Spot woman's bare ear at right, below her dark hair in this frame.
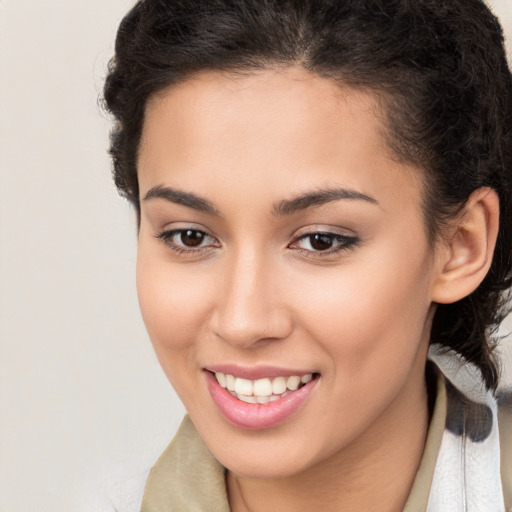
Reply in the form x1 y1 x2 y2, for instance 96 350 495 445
432 187 499 304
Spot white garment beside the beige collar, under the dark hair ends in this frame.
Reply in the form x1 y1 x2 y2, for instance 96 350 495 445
427 347 505 512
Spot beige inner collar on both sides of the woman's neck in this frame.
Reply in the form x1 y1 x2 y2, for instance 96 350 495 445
141 374 447 512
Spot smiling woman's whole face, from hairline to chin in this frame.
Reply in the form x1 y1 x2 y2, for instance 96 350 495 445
137 68 436 477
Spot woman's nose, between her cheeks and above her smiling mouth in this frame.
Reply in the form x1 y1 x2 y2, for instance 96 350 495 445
211 251 293 348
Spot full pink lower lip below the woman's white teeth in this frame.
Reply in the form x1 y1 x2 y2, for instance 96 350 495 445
204 371 318 430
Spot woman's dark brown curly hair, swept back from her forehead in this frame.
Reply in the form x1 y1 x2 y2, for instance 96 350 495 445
104 0 512 389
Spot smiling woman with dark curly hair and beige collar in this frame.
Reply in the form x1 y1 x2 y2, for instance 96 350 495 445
105 0 512 512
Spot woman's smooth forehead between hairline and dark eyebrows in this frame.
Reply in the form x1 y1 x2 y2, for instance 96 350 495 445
138 68 422 214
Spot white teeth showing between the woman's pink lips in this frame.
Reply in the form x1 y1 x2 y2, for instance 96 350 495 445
206 372 319 404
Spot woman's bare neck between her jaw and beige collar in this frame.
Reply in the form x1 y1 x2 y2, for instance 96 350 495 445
227 360 429 512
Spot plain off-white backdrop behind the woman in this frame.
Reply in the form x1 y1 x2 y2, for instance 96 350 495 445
0 0 512 512
